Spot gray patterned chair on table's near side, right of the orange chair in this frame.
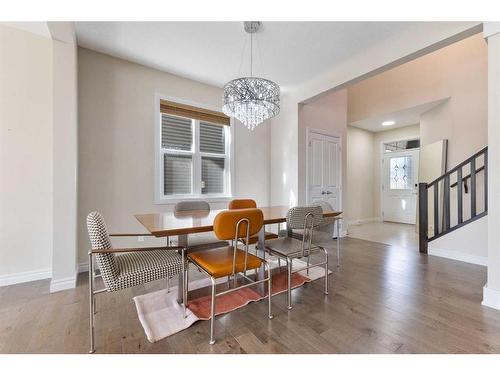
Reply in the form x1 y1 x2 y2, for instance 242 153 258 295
266 206 328 310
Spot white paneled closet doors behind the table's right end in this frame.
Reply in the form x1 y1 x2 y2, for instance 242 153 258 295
307 131 342 210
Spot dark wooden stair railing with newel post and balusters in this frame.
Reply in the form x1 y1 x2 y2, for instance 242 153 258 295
418 147 488 254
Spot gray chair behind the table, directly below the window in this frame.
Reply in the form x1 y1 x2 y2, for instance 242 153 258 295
173 200 228 252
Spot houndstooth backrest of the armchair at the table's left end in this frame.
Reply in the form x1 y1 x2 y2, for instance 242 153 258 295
87 211 119 290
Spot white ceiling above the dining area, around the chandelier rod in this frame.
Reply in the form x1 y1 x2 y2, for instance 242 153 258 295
75 22 425 88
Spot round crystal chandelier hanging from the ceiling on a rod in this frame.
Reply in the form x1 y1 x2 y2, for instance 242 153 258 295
222 21 280 130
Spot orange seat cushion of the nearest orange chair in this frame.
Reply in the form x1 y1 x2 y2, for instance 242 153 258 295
188 246 262 278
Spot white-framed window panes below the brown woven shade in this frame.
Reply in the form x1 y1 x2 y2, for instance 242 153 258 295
159 105 230 199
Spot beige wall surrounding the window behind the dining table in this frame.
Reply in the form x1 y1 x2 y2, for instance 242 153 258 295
78 48 270 263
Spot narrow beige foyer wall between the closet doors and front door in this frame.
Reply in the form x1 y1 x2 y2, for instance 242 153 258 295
345 126 376 224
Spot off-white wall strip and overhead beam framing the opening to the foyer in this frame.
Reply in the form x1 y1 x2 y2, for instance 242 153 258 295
271 22 481 209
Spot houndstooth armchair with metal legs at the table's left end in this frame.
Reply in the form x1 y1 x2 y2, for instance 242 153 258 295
87 212 184 353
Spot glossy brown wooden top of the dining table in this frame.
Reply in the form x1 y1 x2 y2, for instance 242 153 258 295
134 206 342 237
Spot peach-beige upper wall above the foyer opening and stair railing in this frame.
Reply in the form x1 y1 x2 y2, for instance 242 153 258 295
348 34 487 166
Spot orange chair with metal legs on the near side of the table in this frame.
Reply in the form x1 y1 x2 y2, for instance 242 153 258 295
183 208 273 344
